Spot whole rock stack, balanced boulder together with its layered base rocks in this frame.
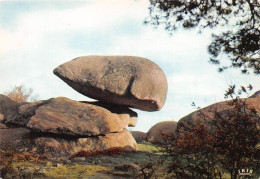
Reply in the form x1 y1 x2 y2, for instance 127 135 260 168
0 56 167 157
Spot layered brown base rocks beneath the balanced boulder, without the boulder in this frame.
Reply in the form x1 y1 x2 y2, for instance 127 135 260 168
0 97 138 157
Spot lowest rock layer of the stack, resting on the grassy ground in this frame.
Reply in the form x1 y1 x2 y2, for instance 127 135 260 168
0 128 138 158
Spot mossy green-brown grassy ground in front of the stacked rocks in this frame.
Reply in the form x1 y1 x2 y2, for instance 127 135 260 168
0 143 166 179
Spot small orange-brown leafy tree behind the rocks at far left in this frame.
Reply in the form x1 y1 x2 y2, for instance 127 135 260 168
5 85 38 103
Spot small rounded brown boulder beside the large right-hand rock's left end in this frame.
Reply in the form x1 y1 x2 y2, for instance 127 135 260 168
147 121 177 144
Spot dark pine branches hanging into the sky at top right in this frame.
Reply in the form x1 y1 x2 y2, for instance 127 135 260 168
145 0 260 74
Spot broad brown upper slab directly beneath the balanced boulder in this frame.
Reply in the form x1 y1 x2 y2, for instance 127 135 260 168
27 97 123 136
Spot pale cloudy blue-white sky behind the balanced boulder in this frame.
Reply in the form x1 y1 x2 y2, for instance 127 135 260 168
0 0 260 132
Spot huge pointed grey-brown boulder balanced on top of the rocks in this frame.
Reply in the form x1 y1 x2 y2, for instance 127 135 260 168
54 56 167 111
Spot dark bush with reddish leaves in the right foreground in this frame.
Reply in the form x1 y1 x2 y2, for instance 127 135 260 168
155 85 260 179
